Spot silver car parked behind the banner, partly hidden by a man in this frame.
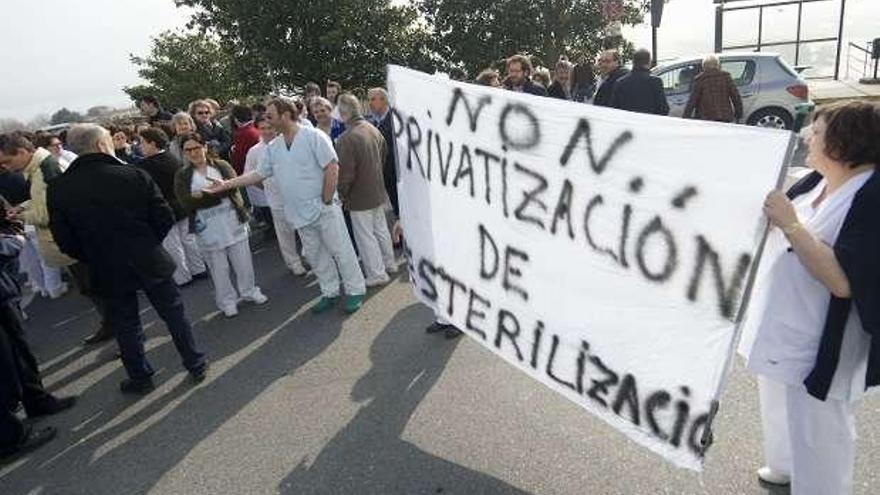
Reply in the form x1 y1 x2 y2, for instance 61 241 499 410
651 52 809 129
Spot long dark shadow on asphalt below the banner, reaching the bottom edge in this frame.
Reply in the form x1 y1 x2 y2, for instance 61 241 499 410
279 304 526 495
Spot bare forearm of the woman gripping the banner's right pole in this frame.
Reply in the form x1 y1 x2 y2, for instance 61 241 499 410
764 190 851 298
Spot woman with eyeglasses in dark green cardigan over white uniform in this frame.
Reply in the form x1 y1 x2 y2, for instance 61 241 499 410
174 133 269 318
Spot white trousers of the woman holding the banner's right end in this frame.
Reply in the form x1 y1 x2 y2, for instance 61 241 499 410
758 375 856 495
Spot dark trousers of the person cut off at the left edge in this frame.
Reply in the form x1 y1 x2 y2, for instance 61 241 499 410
0 301 54 448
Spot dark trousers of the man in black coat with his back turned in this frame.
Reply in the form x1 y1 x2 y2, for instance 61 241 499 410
104 278 205 380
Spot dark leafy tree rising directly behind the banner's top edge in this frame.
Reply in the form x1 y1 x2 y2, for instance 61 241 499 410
419 0 647 76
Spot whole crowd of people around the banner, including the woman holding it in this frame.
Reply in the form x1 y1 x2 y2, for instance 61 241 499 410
0 50 880 494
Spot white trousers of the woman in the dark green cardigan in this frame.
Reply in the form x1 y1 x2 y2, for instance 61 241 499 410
202 239 262 311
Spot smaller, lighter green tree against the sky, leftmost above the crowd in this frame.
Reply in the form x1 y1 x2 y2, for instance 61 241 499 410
123 31 269 108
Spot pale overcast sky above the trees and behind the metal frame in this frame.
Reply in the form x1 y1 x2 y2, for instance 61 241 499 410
0 0 880 121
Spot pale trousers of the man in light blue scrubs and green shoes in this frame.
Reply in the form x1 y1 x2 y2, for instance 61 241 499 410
297 204 367 297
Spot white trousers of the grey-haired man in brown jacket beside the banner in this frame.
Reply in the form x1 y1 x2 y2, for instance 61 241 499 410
351 206 395 282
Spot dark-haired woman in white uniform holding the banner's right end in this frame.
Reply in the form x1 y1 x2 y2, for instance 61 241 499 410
742 102 880 495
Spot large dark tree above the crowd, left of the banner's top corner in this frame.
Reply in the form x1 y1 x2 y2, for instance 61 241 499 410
176 0 433 89
